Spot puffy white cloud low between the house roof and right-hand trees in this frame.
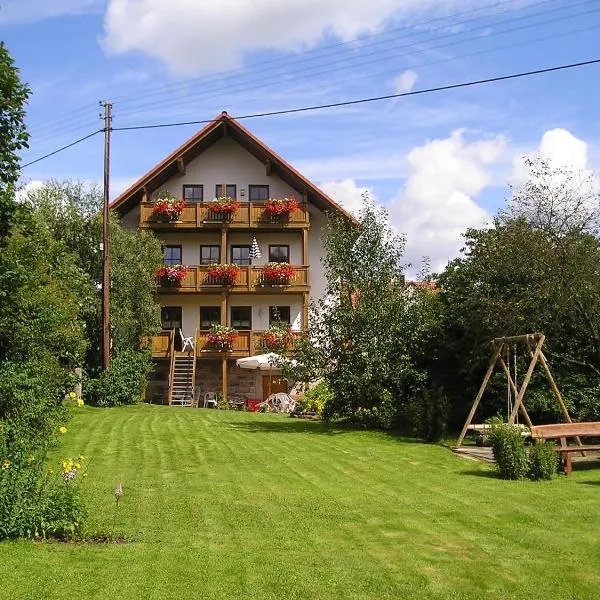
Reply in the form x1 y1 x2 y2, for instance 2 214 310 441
389 130 507 271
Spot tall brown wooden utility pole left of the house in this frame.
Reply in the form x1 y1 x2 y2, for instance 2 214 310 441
100 102 112 371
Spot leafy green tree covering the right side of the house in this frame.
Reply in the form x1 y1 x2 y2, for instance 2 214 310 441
296 198 436 428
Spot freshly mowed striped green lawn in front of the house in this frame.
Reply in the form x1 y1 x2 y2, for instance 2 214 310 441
0 405 600 599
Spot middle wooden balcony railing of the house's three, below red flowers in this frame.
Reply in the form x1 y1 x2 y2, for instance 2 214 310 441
158 265 310 294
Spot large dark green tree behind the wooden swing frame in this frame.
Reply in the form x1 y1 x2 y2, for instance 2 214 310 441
434 161 600 420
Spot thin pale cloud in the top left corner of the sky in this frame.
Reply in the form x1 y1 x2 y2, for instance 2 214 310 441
0 0 104 25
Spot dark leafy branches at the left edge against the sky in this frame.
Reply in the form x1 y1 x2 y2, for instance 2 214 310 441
0 42 29 245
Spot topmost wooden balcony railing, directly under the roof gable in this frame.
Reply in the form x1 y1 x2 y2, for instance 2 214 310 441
140 202 309 231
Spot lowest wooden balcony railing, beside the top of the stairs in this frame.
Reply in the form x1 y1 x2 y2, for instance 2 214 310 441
152 330 301 359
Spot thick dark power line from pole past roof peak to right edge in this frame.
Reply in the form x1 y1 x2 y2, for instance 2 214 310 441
113 58 600 131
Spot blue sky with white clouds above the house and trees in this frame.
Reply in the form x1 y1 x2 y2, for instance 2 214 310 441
0 0 600 270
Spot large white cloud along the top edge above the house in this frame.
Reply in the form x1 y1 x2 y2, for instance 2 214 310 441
104 0 462 75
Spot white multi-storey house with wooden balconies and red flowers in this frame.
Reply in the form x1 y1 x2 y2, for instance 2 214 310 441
112 113 352 404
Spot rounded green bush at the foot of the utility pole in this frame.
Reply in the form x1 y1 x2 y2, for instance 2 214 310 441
83 349 152 406
